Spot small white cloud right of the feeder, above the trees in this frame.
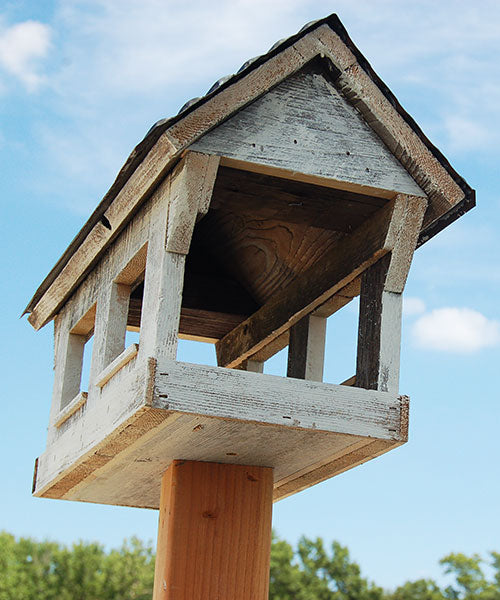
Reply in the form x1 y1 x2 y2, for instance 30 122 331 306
412 307 500 354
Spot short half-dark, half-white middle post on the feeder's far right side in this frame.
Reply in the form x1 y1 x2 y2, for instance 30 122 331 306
287 315 326 381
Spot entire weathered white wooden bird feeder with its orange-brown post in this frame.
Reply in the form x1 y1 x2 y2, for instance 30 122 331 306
26 15 474 600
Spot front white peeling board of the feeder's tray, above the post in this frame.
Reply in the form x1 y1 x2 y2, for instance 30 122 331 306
153 360 408 441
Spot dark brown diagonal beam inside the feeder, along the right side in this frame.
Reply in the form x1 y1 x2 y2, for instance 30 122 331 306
216 198 405 367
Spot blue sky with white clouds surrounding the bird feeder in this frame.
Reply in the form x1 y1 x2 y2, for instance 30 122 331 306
0 0 500 587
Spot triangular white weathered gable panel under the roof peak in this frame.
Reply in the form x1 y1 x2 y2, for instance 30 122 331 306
190 61 425 196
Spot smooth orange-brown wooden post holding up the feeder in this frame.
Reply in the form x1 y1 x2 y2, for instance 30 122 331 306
153 460 273 600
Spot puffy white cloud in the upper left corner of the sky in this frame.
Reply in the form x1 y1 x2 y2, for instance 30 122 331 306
0 21 51 91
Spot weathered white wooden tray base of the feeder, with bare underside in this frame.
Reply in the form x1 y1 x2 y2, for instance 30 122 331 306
33 359 408 509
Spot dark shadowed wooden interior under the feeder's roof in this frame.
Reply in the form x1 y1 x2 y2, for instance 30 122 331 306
128 167 387 341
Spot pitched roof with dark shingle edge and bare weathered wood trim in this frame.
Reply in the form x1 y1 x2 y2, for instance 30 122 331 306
23 15 475 326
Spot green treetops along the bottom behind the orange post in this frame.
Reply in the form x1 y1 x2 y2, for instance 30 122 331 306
0 532 500 600
